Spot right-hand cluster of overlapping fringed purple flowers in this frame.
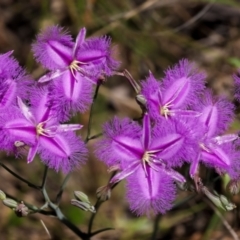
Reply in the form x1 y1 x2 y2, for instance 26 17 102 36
95 60 240 215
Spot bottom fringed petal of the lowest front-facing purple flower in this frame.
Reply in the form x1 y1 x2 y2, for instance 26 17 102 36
127 168 176 215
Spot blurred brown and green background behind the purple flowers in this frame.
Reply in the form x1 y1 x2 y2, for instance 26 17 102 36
0 0 240 240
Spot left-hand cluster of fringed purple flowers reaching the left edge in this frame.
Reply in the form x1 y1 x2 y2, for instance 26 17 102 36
0 26 118 173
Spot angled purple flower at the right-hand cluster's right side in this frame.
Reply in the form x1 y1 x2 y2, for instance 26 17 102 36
190 91 240 178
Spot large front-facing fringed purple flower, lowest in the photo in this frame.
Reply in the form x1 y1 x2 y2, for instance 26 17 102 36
96 114 190 215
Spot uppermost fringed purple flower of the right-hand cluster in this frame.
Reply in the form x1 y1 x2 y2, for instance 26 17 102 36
142 59 205 118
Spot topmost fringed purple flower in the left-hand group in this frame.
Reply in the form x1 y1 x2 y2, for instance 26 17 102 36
33 26 118 117
